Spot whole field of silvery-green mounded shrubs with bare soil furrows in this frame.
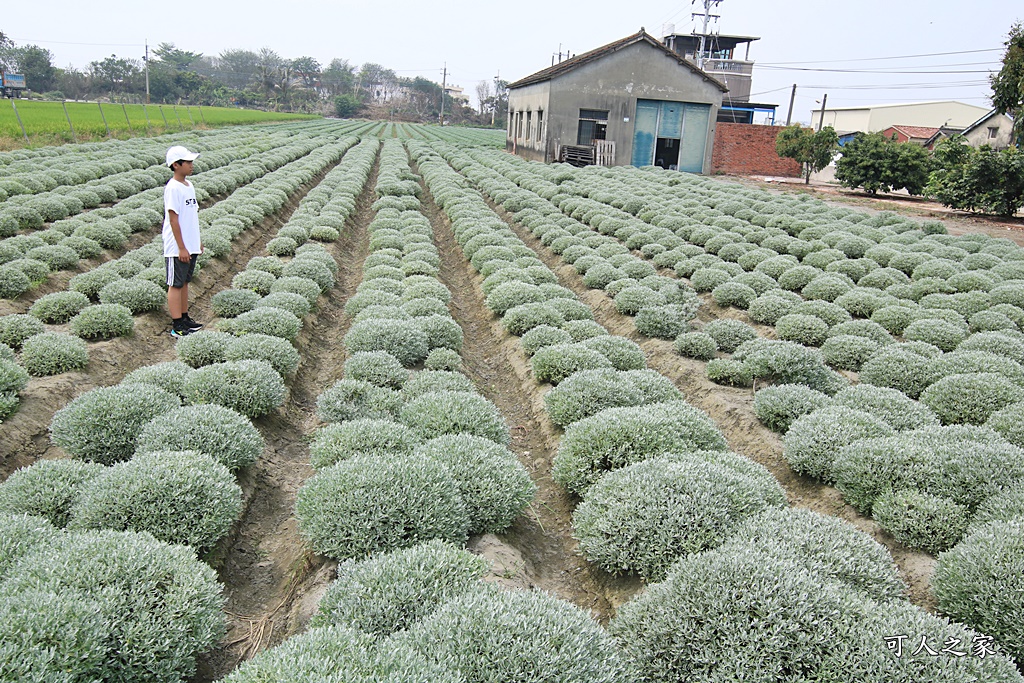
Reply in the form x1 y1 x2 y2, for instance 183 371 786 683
0 121 1024 683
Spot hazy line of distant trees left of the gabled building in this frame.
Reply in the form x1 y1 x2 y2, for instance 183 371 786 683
0 32 508 125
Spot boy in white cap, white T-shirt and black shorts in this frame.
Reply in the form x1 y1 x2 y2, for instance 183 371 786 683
164 145 203 339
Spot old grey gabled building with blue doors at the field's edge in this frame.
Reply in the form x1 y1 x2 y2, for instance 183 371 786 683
507 29 728 173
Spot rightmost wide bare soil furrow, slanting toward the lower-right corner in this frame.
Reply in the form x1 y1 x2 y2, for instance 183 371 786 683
492 200 935 609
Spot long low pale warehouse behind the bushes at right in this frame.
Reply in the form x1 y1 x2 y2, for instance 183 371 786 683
811 100 988 135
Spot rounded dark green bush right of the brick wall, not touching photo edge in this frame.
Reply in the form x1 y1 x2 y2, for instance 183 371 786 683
836 133 932 195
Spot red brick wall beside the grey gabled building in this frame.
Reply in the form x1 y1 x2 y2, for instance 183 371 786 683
711 123 801 178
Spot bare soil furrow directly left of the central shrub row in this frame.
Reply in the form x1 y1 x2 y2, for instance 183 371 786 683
194 147 378 683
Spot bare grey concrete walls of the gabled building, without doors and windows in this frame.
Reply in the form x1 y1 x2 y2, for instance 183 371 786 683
507 42 723 173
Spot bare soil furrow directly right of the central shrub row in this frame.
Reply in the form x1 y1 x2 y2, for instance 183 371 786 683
413 162 640 623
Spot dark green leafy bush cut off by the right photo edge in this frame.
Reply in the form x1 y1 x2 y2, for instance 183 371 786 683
928 135 1024 216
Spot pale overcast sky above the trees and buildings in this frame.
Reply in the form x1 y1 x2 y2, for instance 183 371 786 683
0 0 1024 123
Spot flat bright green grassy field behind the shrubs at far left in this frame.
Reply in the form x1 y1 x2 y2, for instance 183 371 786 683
0 100 317 148
